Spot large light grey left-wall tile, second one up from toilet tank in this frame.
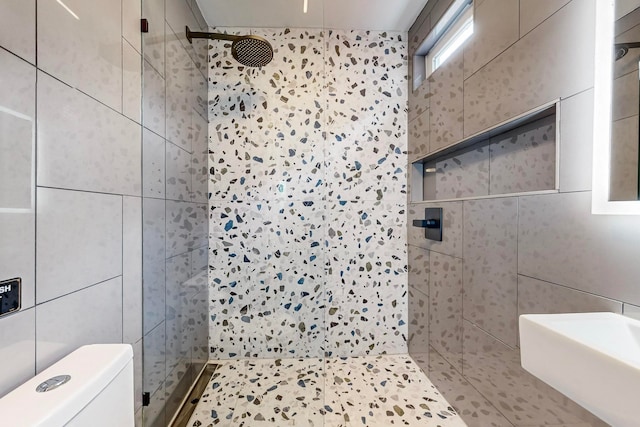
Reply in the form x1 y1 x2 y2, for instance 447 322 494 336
36 188 122 304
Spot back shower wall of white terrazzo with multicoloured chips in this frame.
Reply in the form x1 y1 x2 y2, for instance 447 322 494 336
209 28 407 359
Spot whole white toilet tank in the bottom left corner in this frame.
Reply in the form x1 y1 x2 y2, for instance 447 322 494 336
0 344 134 427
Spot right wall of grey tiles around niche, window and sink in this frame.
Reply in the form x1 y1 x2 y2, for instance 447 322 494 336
408 0 640 427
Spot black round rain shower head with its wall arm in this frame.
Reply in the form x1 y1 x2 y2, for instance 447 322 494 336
187 27 273 67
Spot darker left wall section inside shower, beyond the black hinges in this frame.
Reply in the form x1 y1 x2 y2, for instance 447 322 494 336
142 0 209 426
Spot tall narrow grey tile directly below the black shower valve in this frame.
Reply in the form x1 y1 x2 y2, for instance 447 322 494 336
429 252 462 371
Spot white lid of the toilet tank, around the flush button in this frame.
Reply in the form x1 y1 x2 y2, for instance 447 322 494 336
0 344 133 426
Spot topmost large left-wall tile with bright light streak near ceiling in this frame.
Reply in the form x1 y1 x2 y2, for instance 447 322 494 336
37 0 122 111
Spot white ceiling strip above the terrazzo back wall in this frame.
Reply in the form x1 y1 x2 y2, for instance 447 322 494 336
197 0 427 31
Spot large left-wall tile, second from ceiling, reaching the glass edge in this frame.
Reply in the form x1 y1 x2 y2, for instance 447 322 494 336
38 71 142 196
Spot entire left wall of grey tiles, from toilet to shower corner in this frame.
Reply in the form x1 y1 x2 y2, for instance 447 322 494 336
0 0 208 425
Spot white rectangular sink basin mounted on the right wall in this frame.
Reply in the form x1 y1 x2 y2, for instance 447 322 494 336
520 313 640 427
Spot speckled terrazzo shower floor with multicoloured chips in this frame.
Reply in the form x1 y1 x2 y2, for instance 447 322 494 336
187 355 466 427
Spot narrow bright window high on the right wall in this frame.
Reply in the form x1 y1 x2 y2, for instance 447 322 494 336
413 0 473 90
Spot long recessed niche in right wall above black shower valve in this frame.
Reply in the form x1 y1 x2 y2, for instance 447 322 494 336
411 102 559 201
